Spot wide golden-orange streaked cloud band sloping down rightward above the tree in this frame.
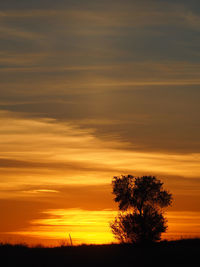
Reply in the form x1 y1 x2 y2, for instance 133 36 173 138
0 112 200 197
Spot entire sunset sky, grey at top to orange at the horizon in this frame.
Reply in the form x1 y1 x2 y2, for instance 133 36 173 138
0 0 200 245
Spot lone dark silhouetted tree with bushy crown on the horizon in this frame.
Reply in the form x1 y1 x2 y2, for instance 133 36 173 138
111 175 172 246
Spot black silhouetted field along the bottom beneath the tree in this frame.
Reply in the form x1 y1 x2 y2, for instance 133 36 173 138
0 239 200 267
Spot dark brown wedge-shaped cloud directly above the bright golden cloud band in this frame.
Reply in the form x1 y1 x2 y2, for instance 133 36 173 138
1 85 200 153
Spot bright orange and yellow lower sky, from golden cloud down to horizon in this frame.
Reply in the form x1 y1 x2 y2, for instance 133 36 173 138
0 111 200 245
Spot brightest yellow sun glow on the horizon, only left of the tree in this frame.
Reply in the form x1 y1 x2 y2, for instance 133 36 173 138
13 209 116 245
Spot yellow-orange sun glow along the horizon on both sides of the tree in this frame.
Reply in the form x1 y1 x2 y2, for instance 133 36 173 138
10 209 200 245
